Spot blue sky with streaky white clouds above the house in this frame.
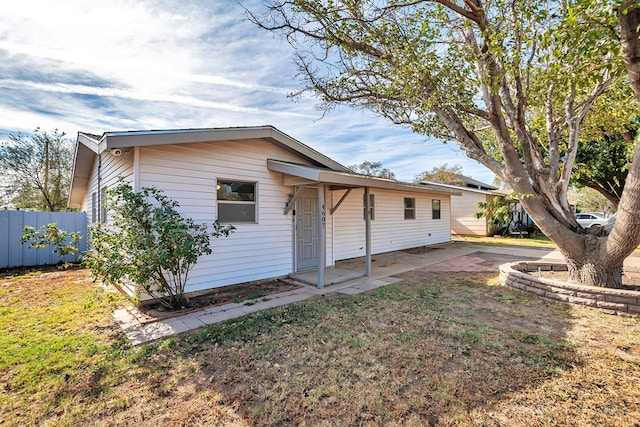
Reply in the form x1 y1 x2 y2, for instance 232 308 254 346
0 0 494 183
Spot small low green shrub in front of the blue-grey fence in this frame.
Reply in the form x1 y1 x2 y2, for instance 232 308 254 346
20 222 82 268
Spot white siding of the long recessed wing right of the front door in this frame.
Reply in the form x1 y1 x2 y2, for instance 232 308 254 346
332 189 451 261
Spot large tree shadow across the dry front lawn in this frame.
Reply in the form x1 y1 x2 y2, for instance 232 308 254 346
114 272 582 425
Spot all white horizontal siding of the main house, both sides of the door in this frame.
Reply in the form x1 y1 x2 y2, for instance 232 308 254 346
83 135 451 292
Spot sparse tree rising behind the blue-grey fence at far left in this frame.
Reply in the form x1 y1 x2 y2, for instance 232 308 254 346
0 128 73 212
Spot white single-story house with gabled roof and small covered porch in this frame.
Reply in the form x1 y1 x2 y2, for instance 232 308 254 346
69 126 460 298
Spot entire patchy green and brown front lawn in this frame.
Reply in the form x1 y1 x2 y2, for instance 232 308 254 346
0 270 640 427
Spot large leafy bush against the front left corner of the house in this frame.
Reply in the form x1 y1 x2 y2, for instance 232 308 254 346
84 180 235 309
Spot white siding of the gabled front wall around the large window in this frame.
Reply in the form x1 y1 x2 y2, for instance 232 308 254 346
138 140 312 292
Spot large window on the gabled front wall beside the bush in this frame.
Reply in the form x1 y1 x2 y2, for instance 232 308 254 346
216 179 257 224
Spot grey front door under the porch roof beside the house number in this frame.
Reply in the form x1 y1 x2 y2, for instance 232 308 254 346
296 189 318 270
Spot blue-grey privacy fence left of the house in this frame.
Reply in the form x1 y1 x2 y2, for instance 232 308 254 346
0 210 87 268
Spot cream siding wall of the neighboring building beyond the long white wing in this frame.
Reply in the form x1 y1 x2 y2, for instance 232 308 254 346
451 190 493 236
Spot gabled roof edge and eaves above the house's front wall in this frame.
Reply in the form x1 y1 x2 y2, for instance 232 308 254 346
68 126 350 207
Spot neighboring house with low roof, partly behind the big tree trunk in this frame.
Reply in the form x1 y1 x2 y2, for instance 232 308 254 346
417 175 505 236
